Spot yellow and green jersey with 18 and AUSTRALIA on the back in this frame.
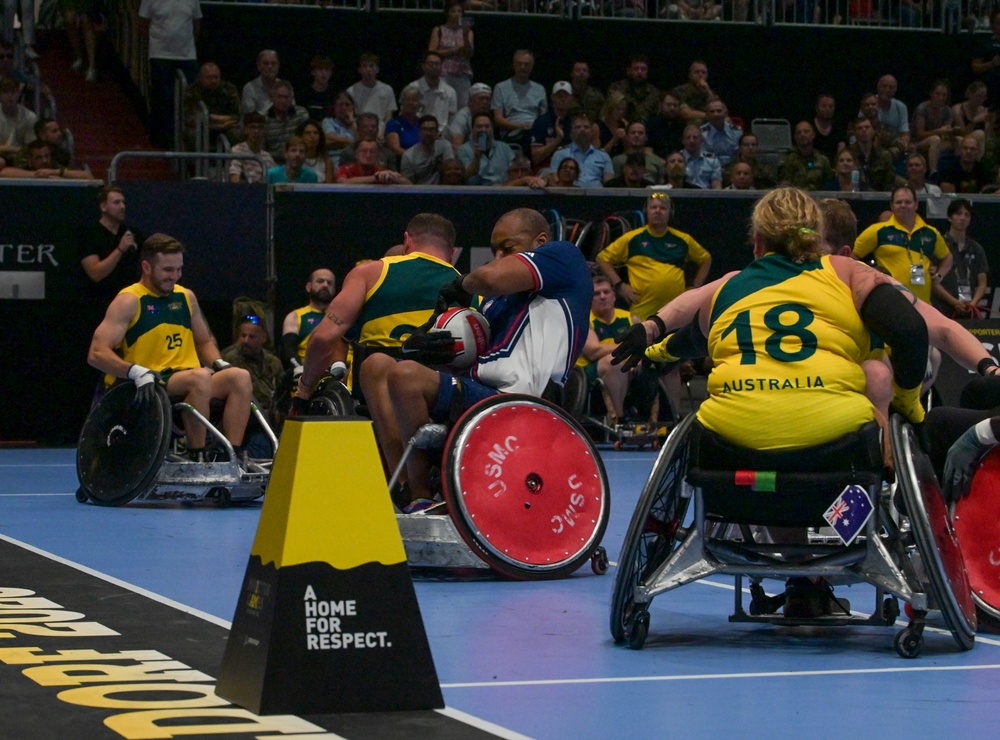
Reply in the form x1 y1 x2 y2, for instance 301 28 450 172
698 254 874 450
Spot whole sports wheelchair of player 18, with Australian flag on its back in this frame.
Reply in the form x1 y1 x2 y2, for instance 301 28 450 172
610 414 977 658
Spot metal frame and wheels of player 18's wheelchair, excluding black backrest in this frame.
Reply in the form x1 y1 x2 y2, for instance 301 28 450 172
610 414 976 658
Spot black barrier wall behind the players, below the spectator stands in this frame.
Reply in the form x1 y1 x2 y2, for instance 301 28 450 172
0 183 1000 444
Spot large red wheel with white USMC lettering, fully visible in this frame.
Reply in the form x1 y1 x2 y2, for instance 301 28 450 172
442 394 611 580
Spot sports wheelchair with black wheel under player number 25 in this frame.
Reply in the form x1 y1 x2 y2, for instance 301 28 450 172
76 383 278 506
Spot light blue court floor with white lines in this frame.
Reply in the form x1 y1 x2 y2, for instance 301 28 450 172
0 449 1000 740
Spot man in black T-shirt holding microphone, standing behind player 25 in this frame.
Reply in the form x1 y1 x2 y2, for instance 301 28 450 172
77 185 145 306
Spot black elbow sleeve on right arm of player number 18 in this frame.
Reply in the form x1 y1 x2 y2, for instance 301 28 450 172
861 283 927 388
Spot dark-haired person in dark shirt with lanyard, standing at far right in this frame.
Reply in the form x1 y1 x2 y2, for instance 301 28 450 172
931 198 990 319
